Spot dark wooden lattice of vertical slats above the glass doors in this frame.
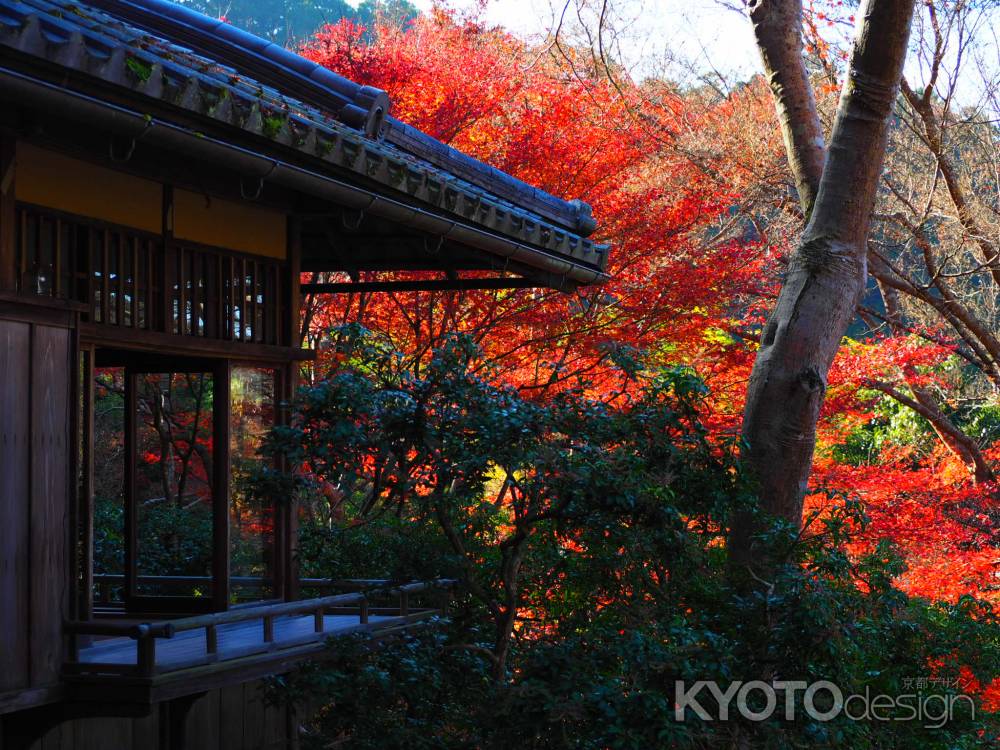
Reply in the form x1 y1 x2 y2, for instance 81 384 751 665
15 203 288 345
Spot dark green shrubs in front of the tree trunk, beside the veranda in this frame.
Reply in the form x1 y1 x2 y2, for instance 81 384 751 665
260 331 1000 750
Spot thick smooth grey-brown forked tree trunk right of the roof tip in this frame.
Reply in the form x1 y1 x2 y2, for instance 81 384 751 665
730 0 914 563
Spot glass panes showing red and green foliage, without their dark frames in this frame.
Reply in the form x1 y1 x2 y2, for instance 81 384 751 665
92 366 279 611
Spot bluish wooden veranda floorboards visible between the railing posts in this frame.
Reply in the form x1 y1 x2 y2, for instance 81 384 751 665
79 615 397 673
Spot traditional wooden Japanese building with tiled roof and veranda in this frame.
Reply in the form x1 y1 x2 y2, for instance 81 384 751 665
0 0 607 750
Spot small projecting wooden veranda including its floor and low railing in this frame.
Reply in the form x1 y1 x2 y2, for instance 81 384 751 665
62 580 454 705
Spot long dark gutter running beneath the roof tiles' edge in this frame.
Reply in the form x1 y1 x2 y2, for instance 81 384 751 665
0 67 610 291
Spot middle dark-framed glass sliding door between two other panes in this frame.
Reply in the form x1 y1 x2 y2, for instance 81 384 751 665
125 362 228 613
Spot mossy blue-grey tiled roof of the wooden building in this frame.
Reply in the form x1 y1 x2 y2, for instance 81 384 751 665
0 0 607 282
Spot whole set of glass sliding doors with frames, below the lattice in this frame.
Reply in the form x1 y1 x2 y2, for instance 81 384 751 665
84 349 282 616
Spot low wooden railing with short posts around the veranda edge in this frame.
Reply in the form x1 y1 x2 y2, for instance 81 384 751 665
64 579 456 678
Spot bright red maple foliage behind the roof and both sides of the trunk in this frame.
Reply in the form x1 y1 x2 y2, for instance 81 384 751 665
304 11 997 620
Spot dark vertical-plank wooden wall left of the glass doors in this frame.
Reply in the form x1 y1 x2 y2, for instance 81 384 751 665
0 305 74 695
